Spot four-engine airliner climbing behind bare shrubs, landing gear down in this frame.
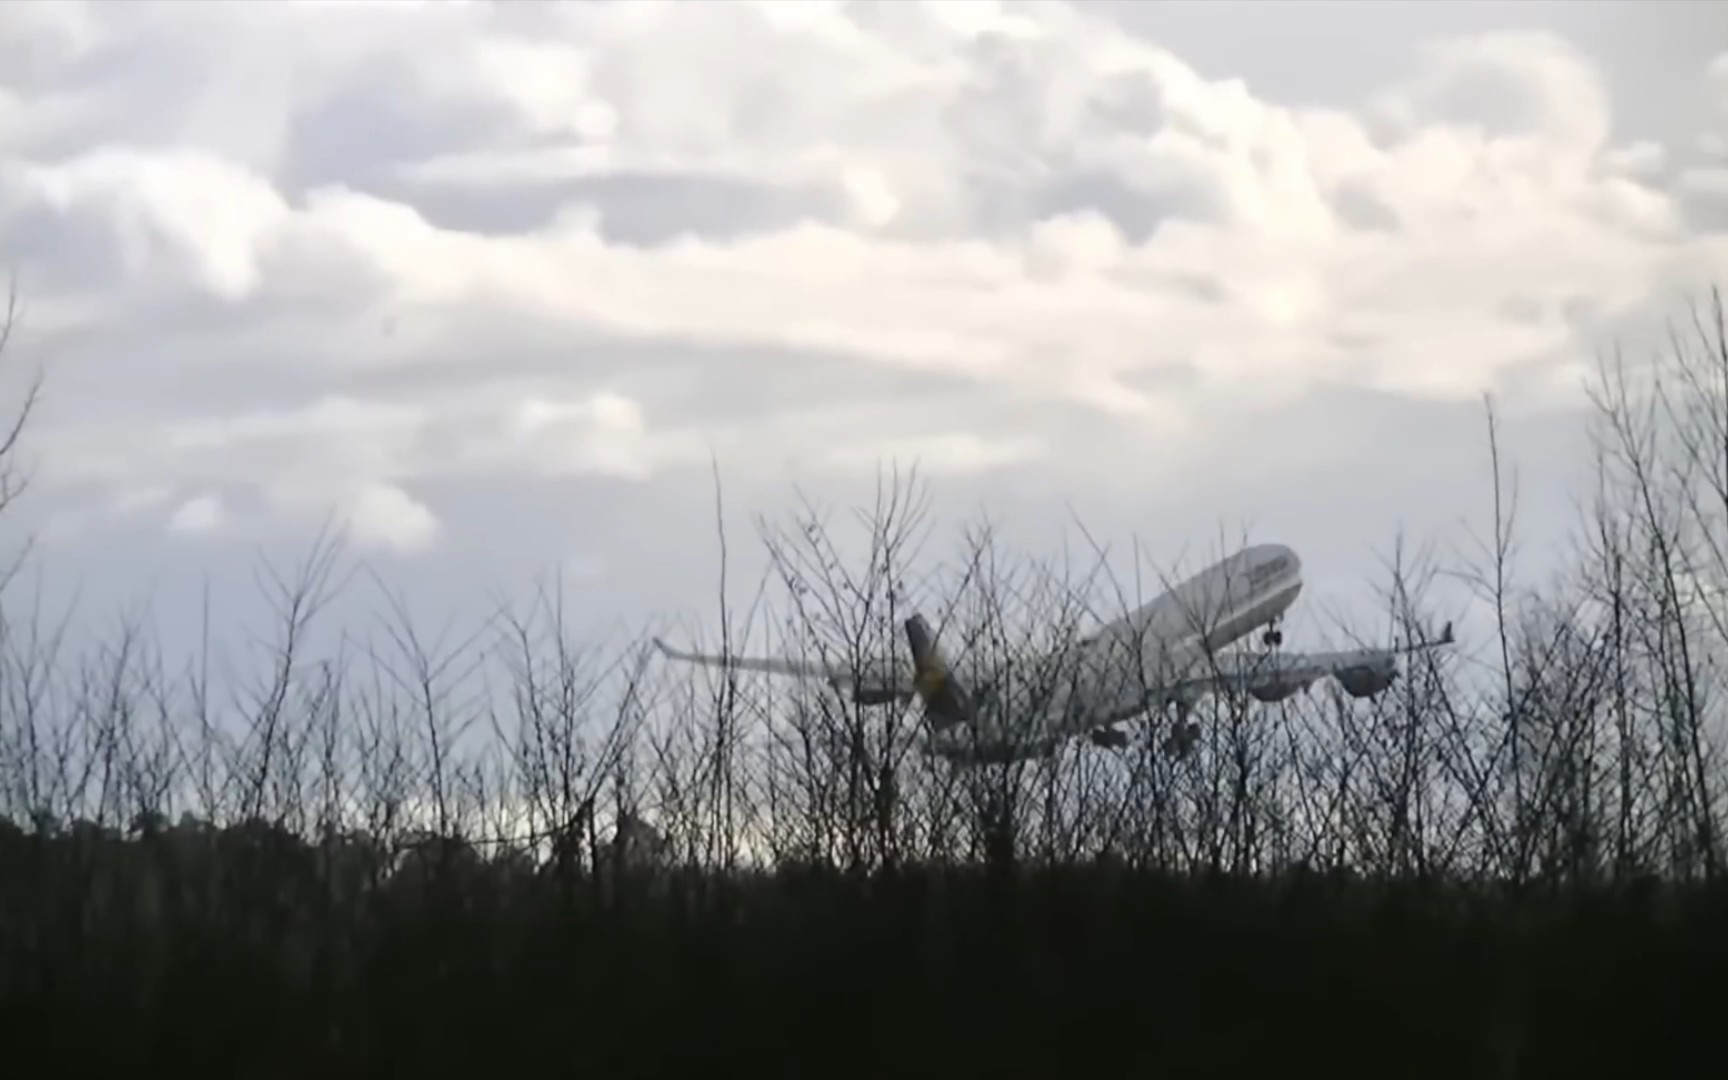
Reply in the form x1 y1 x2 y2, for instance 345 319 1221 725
655 544 1453 766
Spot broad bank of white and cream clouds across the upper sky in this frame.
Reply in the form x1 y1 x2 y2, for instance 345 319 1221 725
0 2 1728 577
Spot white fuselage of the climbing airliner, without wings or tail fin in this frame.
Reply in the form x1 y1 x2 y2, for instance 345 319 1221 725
930 544 1301 760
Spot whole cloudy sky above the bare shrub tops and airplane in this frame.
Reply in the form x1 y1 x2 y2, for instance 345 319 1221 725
0 0 1728 667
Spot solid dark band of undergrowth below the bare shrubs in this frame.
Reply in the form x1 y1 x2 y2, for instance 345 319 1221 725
10 828 1728 1077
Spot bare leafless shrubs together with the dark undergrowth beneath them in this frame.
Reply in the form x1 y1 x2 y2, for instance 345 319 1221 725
0 290 1728 1077
